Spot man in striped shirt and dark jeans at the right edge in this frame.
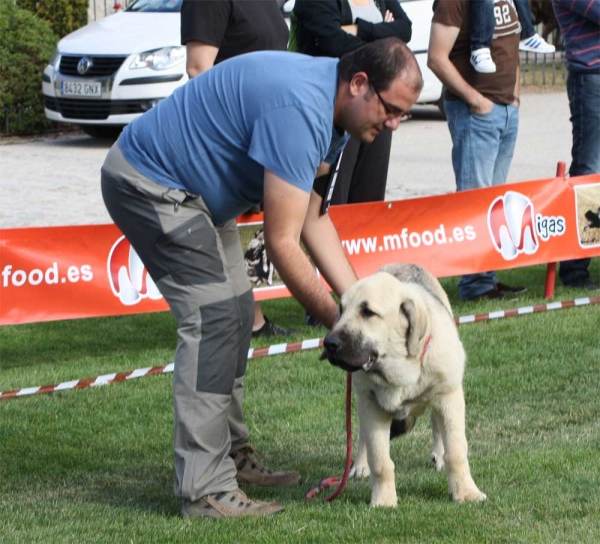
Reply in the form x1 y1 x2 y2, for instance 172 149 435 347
552 0 600 289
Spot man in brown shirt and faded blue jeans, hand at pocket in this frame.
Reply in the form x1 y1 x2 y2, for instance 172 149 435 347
428 0 526 300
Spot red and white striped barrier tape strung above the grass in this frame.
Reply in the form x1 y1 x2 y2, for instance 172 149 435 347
0 297 600 400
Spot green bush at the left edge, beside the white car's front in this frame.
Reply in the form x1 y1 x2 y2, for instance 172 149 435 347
0 0 58 134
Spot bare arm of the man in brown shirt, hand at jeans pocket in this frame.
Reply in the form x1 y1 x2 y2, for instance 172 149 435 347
427 23 494 113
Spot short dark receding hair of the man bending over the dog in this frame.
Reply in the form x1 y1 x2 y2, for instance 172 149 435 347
339 38 423 92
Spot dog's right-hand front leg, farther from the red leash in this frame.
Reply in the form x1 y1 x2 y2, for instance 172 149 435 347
432 389 487 502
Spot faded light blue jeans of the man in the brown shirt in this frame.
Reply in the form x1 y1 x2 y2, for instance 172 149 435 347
444 100 519 300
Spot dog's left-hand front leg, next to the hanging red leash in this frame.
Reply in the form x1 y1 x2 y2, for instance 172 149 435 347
357 396 398 506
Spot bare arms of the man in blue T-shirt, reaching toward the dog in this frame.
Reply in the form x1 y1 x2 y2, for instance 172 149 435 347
264 170 356 327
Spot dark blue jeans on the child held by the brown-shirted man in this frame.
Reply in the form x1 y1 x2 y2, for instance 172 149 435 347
469 0 535 51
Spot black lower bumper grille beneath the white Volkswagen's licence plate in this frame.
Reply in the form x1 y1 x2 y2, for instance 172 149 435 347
44 96 148 120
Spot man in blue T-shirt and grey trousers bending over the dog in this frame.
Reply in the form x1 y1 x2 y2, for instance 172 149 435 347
102 39 423 517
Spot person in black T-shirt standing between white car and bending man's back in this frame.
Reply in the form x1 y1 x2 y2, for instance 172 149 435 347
181 0 298 338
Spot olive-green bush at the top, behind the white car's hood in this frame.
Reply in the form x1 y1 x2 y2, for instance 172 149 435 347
16 0 88 38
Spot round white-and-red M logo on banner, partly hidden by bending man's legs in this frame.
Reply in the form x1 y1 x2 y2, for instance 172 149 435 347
107 236 162 306
